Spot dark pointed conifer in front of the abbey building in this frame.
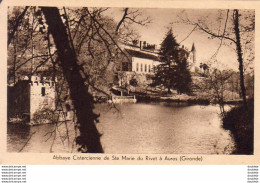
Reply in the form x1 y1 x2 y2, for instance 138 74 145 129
151 29 191 94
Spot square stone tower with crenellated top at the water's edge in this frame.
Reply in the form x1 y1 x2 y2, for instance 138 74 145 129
8 76 55 123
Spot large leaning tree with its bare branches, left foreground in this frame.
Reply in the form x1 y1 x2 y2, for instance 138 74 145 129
9 7 154 153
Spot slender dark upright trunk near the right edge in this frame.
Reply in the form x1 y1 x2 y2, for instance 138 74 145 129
234 10 247 108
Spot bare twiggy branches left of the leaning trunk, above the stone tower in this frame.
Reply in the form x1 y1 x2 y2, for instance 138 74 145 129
8 7 53 84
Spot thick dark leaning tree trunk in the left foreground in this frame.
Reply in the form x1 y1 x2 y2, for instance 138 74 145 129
41 7 103 153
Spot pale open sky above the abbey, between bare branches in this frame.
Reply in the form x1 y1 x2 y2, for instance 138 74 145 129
103 8 254 70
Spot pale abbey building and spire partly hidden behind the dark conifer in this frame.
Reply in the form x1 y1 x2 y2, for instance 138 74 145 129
118 41 200 91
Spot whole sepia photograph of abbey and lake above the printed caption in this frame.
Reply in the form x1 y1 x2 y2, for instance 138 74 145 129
6 6 255 155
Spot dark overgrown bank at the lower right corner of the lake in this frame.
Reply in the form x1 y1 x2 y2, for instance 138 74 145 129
223 99 254 154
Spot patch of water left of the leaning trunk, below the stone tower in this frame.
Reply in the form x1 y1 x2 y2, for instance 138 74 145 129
7 122 76 152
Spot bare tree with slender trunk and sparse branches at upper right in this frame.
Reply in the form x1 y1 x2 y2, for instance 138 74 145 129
179 9 255 108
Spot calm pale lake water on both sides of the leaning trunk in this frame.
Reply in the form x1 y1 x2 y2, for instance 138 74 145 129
7 103 234 154
